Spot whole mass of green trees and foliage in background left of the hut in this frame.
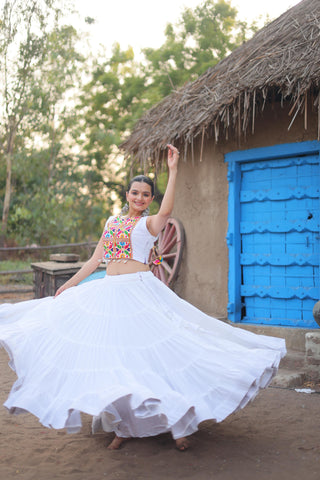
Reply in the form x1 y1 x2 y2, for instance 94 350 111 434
0 0 255 244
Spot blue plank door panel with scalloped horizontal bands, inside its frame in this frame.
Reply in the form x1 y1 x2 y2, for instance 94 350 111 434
240 156 320 327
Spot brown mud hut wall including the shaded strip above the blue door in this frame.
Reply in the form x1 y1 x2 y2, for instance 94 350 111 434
173 104 318 318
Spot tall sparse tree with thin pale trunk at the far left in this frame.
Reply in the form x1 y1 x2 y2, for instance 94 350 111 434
0 0 81 242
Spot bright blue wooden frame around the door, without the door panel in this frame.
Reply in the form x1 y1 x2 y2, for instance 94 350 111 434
225 140 320 323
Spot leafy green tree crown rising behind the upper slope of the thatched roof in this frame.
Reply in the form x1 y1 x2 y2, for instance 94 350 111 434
143 0 256 102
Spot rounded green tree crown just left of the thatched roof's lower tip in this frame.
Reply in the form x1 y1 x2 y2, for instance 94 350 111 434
78 44 145 160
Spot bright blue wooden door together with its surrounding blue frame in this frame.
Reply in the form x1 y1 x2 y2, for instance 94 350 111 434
226 142 320 328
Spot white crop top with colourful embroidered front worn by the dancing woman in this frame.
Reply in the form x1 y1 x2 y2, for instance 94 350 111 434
103 215 157 263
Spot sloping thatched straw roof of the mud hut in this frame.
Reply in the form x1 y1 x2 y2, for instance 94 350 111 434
121 0 320 164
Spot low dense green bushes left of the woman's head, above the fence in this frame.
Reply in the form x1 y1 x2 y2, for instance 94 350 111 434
9 144 110 245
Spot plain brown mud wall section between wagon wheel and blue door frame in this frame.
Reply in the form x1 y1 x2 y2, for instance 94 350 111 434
173 142 228 316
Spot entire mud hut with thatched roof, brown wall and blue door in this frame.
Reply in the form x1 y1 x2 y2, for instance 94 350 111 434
122 0 320 328
